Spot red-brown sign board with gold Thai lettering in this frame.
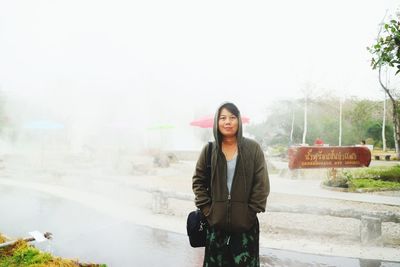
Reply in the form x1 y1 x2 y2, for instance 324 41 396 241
288 146 371 169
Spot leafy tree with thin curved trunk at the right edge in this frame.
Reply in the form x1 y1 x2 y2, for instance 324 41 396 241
368 13 400 158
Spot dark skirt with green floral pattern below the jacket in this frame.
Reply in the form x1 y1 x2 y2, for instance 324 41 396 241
203 220 260 267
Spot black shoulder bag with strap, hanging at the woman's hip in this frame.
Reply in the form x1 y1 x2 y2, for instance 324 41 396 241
186 142 212 248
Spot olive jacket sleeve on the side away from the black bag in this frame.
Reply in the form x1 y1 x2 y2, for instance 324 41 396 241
249 145 270 213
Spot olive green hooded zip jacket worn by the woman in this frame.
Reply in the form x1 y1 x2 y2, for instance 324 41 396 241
192 104 270 232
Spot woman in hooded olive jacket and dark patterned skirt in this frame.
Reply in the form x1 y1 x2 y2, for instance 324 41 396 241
193 103 269 267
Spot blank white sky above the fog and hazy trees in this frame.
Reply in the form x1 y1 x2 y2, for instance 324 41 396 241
0 0 399 150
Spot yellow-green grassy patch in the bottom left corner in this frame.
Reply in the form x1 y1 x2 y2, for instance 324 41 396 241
0 238 106 267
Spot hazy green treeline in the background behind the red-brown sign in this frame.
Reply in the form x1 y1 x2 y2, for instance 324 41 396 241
246 95 394 148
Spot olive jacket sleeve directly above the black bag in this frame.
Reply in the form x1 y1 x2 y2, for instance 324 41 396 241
192 145 211 213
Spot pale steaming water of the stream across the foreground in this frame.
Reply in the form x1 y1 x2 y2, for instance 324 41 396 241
0 185 400 267
